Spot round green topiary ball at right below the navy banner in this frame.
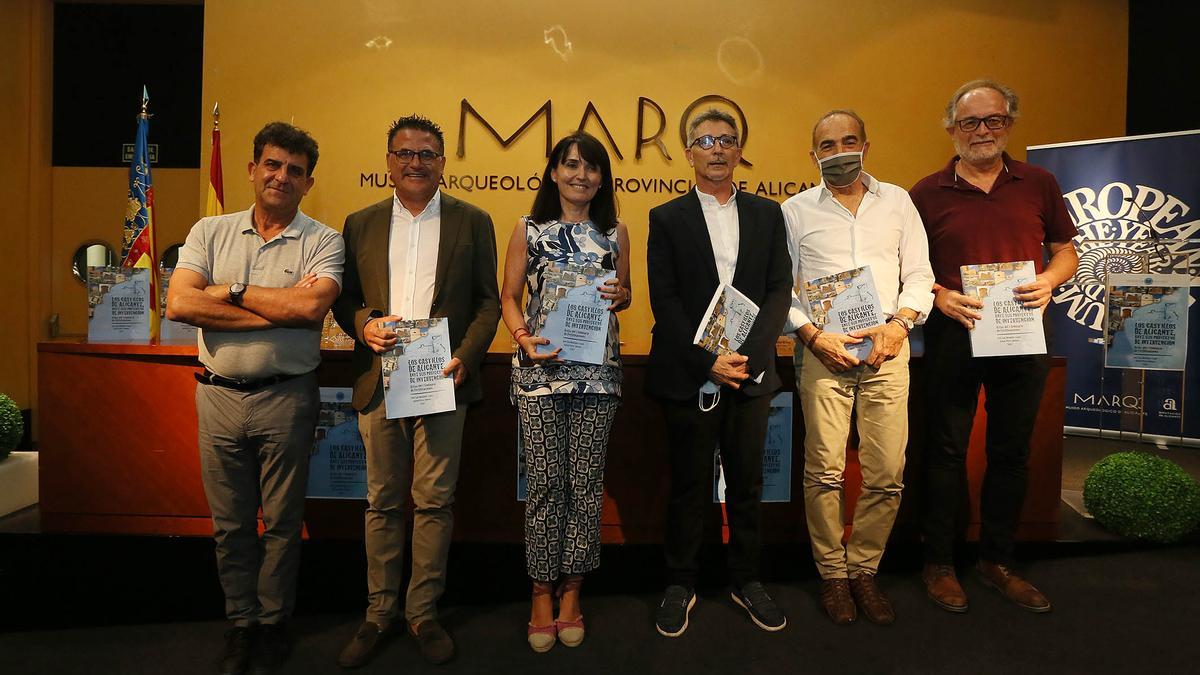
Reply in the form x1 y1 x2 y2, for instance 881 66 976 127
1084 453 1200 543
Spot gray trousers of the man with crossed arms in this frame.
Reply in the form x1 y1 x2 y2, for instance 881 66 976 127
196 372 320 626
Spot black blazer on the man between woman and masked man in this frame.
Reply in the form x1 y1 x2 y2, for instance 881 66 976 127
646 191 792 400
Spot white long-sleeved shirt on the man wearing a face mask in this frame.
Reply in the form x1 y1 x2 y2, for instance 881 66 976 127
784 172 934 334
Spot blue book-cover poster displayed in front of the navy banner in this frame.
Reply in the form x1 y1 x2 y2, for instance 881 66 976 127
1104 274 1192 371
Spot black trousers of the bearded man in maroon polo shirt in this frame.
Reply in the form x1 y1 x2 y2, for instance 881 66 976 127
922 310 1050 565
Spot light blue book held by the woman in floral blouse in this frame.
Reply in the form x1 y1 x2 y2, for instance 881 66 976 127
533 263 617 365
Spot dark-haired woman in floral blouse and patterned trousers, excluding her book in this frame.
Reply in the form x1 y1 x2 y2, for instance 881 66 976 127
500 132 630 652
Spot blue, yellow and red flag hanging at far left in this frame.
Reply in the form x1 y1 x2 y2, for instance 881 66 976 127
121 86 158 339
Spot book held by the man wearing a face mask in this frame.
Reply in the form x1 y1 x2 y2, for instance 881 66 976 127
804 265 883 360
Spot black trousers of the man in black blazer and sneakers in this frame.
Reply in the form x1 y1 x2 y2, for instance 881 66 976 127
662 388 770 589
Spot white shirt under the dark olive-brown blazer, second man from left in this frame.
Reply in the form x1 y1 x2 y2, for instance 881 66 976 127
388 190 442 321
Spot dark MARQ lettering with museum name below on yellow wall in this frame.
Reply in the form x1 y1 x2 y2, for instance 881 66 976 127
359 94 811 198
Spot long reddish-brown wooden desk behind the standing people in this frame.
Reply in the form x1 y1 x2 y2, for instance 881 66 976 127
38 341 1066 543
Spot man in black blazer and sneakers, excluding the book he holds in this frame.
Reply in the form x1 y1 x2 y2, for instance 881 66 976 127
646 109 792 638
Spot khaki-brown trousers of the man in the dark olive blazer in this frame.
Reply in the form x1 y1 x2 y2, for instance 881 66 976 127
359 394 467 628
